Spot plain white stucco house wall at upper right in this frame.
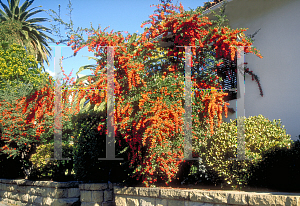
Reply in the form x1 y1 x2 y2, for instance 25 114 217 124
212 0 300 140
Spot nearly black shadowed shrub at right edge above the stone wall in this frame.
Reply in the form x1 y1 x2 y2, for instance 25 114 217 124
249 140 300 192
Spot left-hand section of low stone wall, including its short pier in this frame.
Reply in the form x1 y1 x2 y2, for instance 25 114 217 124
0 179 114 206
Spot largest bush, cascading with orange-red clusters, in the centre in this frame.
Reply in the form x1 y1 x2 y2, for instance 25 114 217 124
55 1 261 186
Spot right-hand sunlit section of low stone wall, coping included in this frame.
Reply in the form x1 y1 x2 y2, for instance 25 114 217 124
114 187 300 206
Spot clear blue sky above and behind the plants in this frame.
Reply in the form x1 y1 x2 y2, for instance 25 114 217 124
27 0 205 80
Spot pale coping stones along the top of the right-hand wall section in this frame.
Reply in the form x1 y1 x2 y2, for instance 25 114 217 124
114 186 300 206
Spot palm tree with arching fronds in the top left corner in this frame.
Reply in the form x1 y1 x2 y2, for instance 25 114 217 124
0 0 54 66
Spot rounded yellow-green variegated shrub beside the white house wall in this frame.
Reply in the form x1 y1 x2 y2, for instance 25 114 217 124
191 115 292 188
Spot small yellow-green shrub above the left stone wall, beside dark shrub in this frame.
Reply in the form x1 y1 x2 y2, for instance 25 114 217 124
29 143 73 181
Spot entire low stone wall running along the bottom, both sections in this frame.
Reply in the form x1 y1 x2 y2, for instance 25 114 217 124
0 179 300 206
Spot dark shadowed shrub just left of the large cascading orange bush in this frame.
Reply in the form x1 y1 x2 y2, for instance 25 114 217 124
72 110 131 182
